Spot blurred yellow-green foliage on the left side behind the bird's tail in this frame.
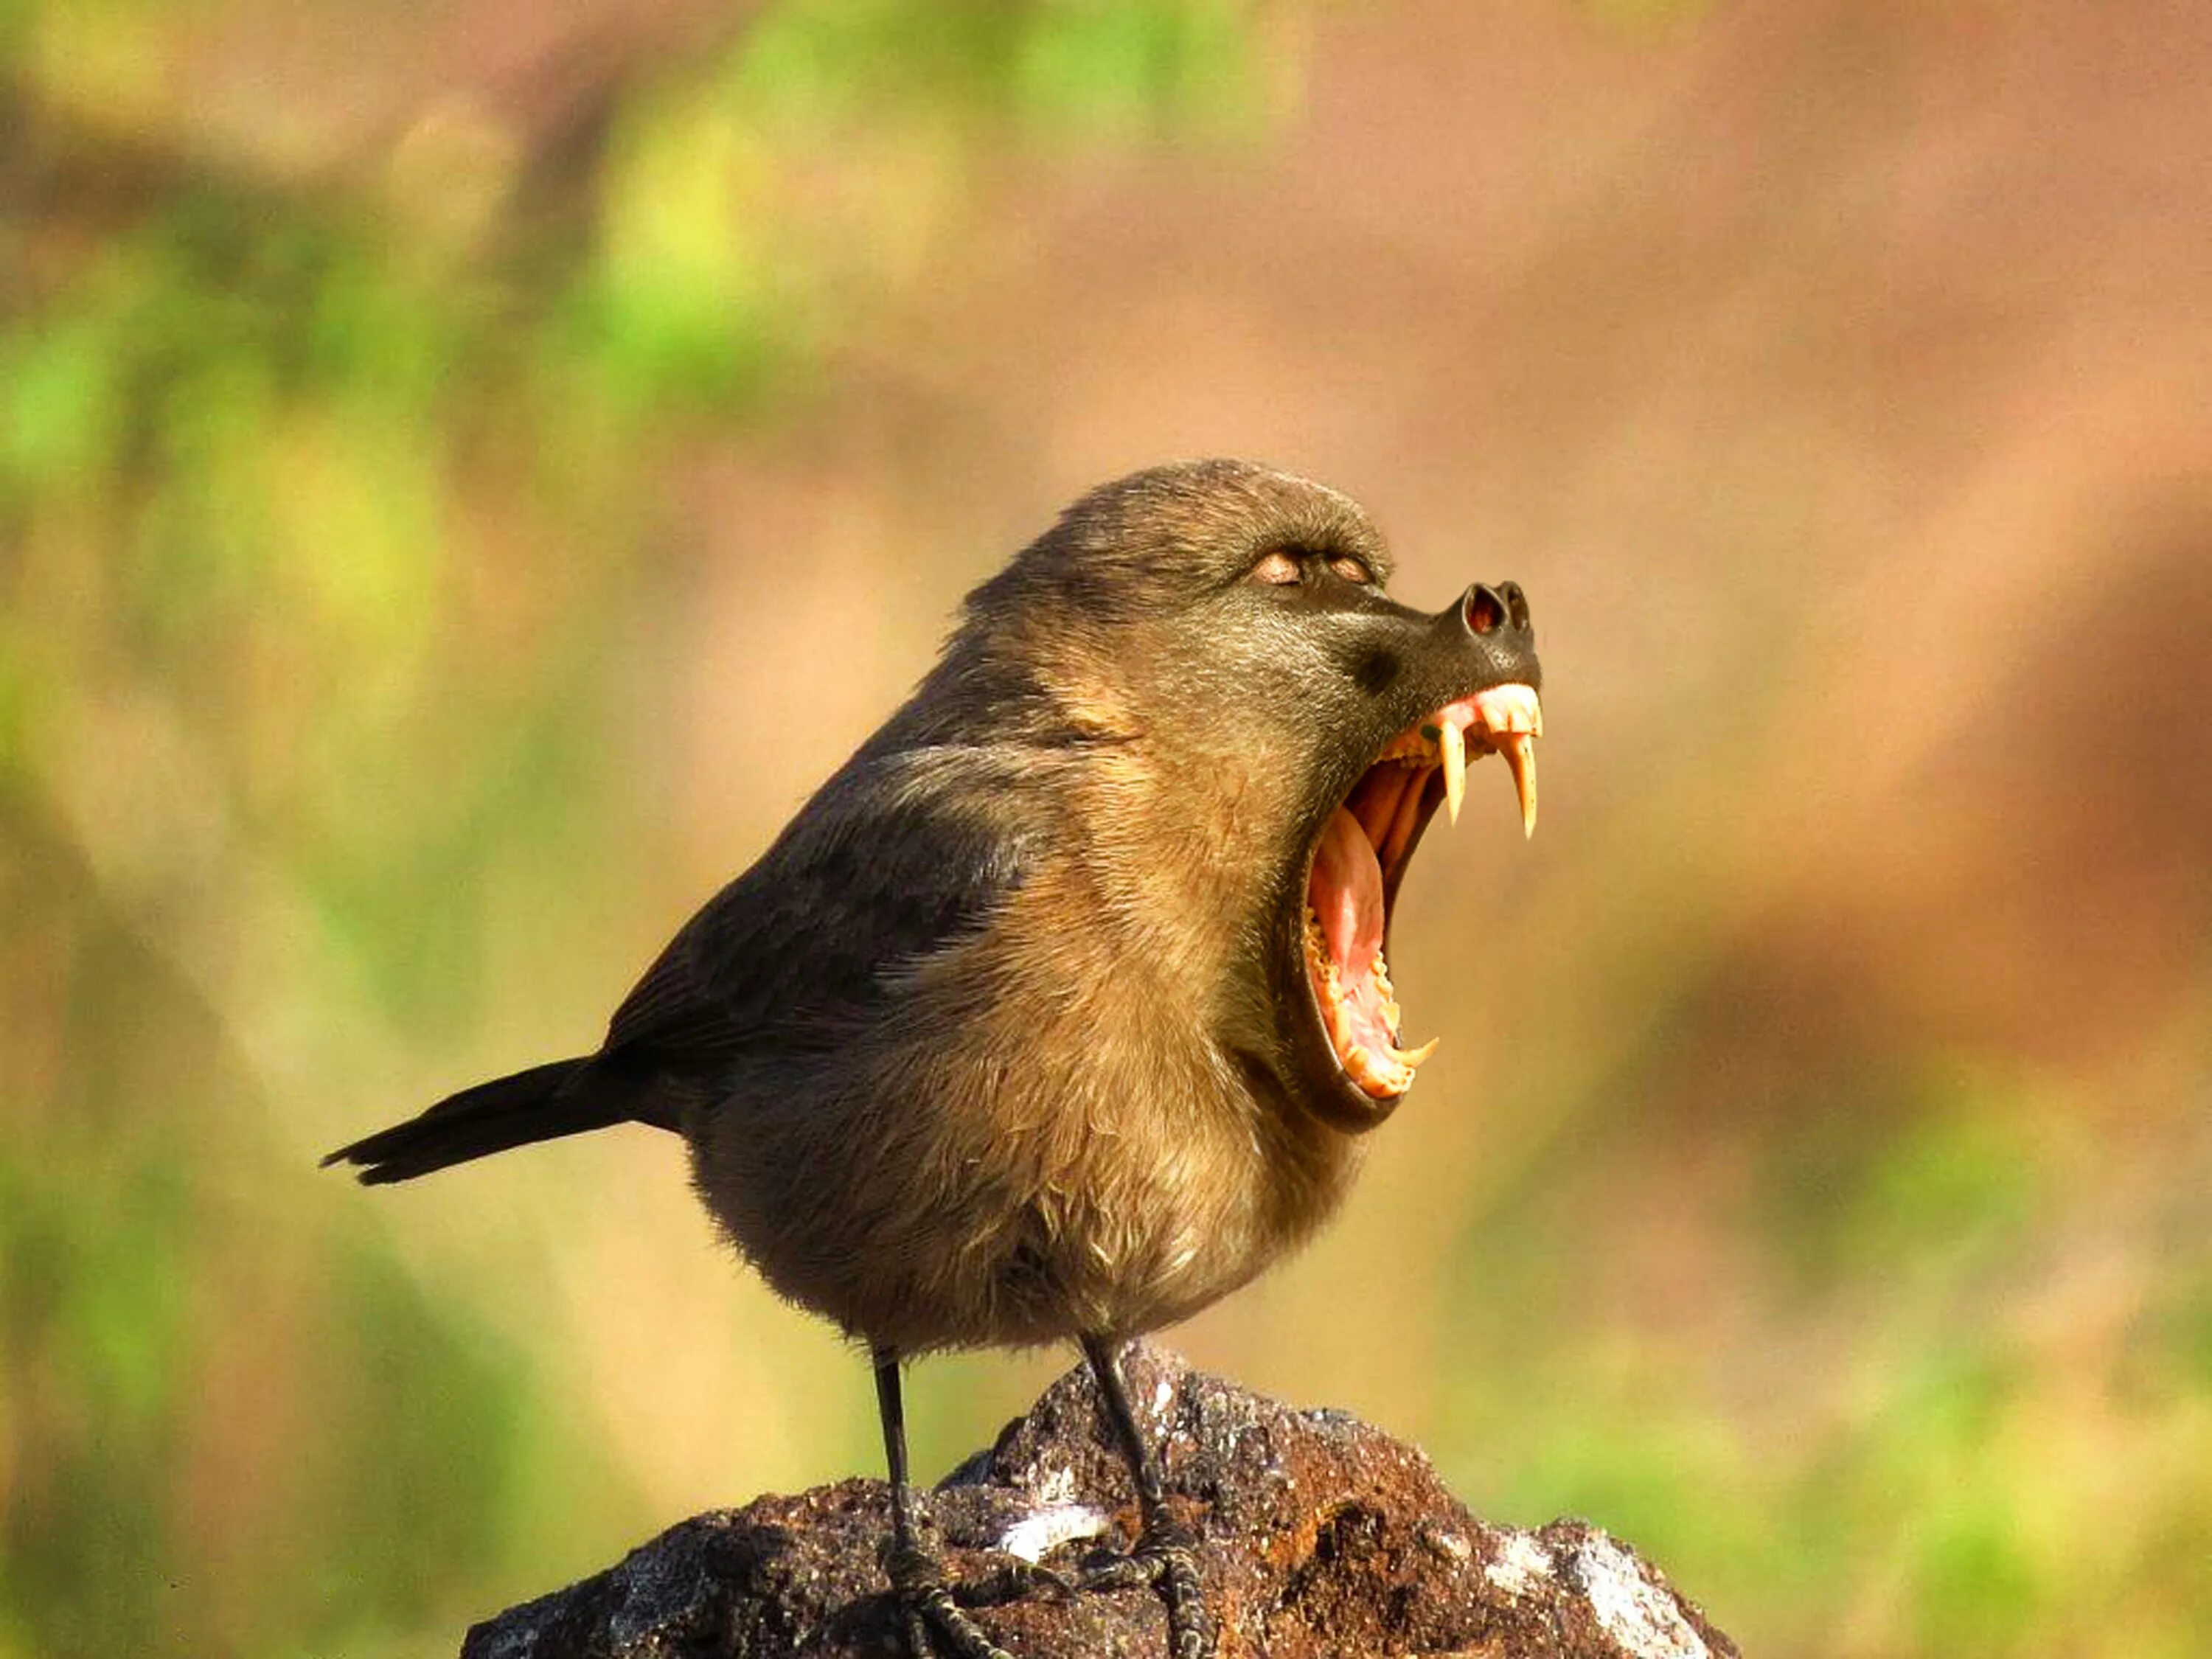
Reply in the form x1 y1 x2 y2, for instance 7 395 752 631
0 0 1274 1659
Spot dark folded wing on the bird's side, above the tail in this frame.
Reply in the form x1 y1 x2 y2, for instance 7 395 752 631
606 748 1046 1075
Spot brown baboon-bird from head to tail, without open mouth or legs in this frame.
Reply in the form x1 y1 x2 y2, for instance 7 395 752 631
336 462 1535 1354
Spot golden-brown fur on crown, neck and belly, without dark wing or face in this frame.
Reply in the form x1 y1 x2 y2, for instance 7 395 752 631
686 462 1416 1352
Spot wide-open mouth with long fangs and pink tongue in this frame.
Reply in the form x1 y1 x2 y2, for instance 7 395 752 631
1305 684 1544 1099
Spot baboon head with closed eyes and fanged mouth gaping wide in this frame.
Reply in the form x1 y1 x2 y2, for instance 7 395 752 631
940 460 1542 1133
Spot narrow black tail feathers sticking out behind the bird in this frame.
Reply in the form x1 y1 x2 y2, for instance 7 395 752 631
323 1057 653 1186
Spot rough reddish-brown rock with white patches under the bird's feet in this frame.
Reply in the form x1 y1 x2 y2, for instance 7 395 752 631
462 1347 1736 1659
